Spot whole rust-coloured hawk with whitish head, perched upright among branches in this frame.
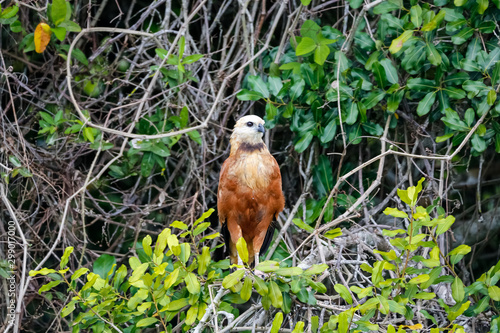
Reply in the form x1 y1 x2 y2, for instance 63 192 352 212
217 116 285 265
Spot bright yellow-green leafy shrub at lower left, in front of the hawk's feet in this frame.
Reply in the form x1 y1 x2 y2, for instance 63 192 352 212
30 209 328 332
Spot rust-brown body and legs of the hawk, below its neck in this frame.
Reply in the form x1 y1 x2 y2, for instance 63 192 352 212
217 150 285 263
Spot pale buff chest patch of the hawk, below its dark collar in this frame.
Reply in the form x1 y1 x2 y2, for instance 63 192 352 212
231 153 273 190
